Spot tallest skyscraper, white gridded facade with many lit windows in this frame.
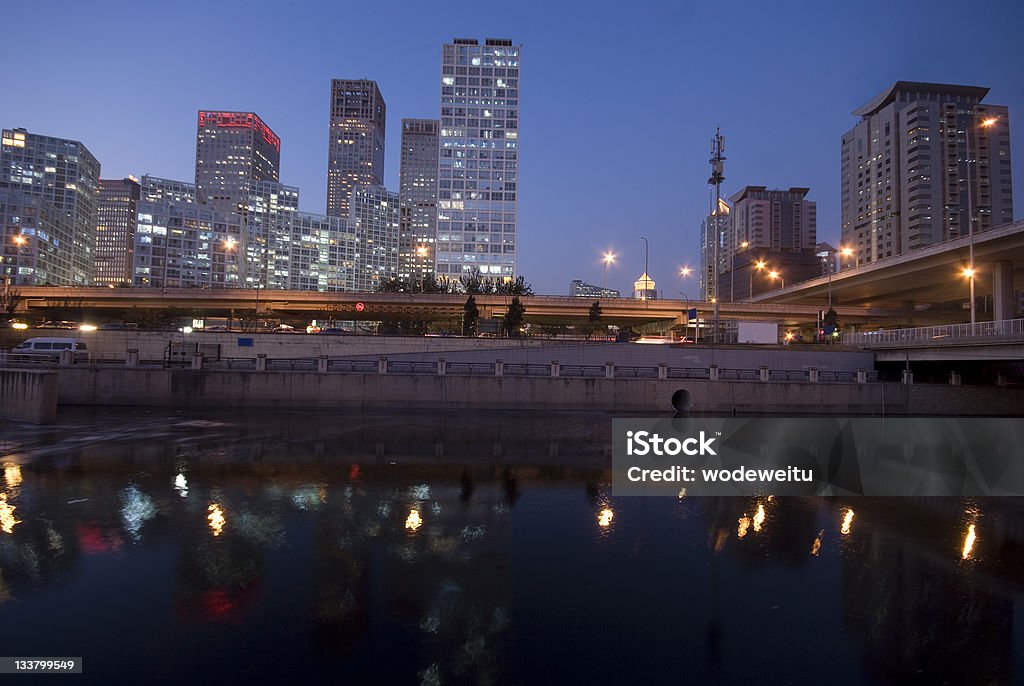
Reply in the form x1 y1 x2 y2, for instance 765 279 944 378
436 38 520 278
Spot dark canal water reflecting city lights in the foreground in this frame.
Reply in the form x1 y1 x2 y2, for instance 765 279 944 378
0 409 1024 685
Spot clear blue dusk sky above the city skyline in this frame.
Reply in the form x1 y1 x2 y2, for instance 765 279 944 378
0 0 1024 298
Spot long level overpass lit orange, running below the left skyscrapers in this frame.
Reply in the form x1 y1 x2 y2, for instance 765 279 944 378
6 287 912 327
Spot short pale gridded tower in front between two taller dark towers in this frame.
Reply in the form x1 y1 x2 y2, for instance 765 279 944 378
348 185 399 291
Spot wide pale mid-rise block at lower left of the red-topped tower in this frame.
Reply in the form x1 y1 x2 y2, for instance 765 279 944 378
132 181 246 289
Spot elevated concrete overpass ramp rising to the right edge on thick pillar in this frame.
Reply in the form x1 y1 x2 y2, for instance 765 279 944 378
750 221 1024 325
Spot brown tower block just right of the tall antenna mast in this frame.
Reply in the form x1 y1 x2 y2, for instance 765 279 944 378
718 185 821 302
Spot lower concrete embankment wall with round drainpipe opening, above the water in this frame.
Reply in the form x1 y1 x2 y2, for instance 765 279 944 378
49 367 1024 416
